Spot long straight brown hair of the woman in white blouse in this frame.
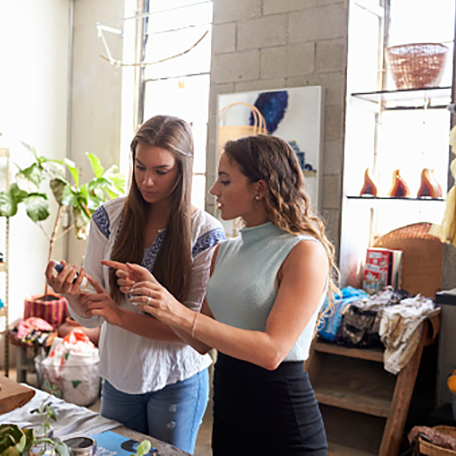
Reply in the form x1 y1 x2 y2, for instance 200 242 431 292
109 116 193 302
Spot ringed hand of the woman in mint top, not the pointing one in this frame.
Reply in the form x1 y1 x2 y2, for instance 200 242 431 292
130 276 194 327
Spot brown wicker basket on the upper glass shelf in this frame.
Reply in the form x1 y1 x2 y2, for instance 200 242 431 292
386 43 448 89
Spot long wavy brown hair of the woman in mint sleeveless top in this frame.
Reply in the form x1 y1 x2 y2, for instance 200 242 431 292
224 135 340 314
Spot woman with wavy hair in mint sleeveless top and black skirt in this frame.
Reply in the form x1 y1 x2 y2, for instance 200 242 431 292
107 135 338 456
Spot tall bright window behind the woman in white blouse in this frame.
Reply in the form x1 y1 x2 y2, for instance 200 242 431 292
138 0 212 209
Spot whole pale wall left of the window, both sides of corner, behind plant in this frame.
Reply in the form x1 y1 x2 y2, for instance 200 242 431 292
0 0 131 364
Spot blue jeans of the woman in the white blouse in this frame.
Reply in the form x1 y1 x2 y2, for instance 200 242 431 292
100 369 209 454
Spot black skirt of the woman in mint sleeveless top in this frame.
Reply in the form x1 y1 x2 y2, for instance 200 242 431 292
212 352 327 456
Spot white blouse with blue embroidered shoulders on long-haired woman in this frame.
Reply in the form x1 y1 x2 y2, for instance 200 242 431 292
70 198 226 394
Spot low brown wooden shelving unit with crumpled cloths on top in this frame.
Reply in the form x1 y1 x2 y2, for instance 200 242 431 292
306 317 438 456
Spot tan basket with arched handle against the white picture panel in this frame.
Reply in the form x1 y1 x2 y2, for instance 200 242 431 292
218 101 268 157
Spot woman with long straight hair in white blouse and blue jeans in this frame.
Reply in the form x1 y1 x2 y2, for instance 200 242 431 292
46 116 225 453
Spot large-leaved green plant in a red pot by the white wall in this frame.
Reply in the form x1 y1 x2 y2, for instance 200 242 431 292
0 143 125 326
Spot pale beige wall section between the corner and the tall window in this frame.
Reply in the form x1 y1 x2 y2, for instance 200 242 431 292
67 0 136 264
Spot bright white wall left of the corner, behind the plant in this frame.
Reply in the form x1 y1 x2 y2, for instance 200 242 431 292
0 0 70 328
